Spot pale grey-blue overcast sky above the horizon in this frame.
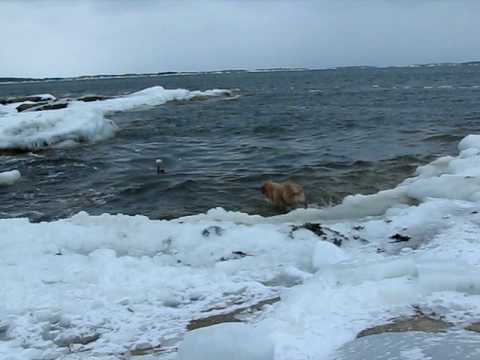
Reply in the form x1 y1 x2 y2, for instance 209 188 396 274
0 0 480 77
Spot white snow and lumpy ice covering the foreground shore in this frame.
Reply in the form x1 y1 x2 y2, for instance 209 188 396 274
0 136 480 360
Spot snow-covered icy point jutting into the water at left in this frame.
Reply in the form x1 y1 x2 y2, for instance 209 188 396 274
0 86 230 150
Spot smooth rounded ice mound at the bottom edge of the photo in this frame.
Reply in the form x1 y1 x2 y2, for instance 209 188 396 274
178 323 274 360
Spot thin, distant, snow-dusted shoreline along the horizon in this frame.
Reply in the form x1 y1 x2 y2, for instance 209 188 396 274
0 61 480 85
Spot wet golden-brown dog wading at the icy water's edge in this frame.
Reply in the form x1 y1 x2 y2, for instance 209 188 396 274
260 180 307 210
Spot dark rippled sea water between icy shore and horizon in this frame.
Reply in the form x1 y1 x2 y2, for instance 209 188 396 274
0 65 480 221
